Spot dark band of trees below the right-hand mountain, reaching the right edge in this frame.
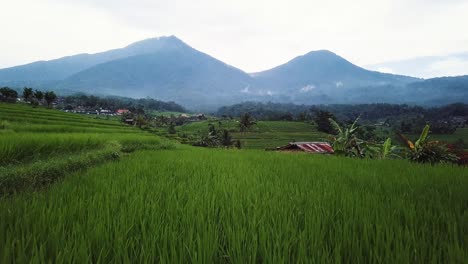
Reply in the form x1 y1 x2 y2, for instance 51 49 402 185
216 102 468 134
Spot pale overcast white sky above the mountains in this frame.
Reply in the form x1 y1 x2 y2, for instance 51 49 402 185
0 0 468 75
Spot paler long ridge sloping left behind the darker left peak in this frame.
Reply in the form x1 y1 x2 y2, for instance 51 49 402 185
0 36 187 86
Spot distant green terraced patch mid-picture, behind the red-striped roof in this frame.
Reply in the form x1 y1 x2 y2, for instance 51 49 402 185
177 121 326 149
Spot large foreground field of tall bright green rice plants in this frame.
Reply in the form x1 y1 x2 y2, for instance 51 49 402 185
0 147 468 263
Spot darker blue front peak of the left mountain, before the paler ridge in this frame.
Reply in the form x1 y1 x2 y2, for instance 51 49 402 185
57 41 252 107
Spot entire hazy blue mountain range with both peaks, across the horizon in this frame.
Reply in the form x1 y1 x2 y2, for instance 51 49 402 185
0 36 468 109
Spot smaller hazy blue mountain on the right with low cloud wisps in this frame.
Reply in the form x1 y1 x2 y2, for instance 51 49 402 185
252 50 419 102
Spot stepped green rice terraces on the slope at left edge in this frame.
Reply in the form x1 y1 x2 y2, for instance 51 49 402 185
0 104 172 195
